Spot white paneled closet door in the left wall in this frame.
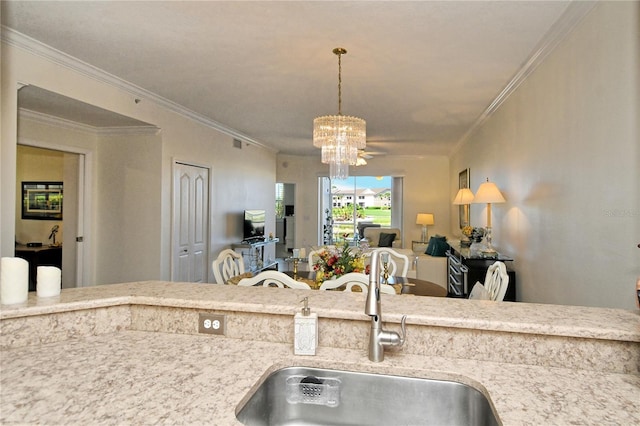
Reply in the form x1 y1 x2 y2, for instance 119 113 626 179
171 162 209 283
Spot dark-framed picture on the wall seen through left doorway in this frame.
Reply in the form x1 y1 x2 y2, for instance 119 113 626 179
22 181 63 220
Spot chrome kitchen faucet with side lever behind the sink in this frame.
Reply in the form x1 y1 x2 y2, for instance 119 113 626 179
364 250 407 362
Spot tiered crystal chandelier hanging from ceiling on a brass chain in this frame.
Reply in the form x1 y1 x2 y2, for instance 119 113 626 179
313 47 367 179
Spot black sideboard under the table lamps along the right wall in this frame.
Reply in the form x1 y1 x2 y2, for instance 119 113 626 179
447 245 516 302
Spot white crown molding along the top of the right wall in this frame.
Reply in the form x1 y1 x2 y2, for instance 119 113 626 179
451 1 597 154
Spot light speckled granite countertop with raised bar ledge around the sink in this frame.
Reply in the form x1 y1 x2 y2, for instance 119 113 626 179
0 282 640 426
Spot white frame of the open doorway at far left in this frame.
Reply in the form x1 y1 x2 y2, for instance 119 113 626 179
17 137 94 287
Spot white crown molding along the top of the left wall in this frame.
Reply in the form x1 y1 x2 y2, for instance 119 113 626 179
0 25 276 152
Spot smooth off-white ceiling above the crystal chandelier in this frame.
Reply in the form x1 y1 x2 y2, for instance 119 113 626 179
1 1 570 155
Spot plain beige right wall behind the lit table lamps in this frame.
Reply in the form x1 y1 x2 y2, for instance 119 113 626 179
450 2 640 309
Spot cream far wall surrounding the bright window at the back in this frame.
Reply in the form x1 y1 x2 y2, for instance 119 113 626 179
277 155 457 248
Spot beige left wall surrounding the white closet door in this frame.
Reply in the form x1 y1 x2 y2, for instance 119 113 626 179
0 42 275 284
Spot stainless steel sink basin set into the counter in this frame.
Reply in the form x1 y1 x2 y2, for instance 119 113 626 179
236 367 501 426
